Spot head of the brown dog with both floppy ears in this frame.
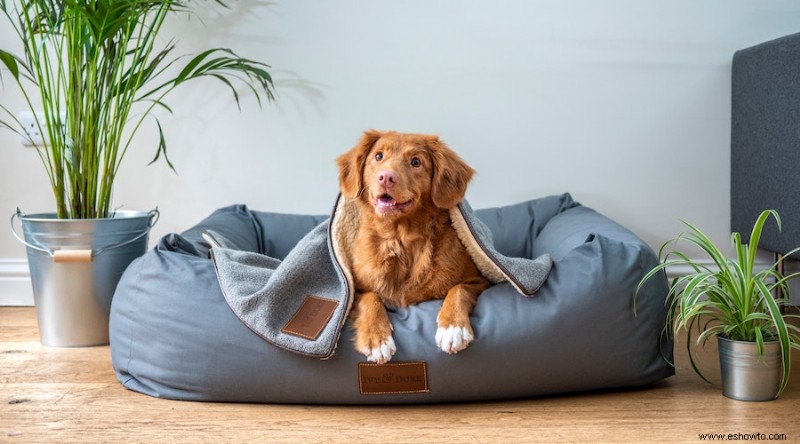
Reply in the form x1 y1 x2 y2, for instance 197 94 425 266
337 130 475 216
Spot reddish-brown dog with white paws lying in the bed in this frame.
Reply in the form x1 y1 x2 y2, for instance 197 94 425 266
337 130 490 364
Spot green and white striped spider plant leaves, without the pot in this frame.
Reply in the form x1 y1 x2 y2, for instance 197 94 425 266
637 210 800 395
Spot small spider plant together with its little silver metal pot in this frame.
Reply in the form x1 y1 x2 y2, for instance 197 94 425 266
639 210 800 401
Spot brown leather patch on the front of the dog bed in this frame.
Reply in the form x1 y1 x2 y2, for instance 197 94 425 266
358 362 428 395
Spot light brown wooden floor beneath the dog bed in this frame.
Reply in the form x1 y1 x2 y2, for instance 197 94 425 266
0 307 800 443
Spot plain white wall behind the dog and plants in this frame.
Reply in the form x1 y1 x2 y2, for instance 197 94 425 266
0 0 800 304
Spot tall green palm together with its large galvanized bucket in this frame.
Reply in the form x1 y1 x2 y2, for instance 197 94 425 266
0 0 273 346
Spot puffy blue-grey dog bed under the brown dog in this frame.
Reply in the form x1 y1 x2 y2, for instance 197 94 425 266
110 194 674 404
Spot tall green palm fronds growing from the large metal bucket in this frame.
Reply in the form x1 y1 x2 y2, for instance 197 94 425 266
0 0 274 219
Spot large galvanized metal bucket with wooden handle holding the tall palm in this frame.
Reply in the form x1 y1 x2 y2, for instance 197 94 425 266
11 209 159 347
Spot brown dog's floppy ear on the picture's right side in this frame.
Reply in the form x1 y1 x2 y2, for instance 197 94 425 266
425 136 475 208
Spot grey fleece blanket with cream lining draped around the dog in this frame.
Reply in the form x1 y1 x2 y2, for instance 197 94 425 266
209 195 552 359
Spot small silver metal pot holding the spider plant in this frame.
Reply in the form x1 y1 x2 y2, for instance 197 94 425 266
717 336 783 401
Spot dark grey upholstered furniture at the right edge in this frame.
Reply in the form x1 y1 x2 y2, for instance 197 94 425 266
731 33 800 258
